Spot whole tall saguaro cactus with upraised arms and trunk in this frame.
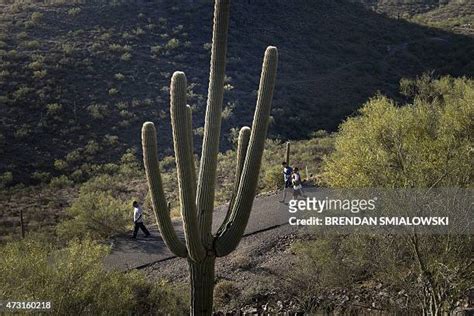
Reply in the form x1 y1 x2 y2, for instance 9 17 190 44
142 0 278 315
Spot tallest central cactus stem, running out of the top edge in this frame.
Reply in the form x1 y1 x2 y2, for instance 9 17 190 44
197 0 230 245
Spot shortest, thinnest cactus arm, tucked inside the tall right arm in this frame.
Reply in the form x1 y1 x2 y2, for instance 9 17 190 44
217 126 250 235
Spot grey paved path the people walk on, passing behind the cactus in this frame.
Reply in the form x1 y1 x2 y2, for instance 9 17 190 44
104 190 313 270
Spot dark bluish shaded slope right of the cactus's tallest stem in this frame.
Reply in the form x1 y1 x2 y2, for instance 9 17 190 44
206 0 474 138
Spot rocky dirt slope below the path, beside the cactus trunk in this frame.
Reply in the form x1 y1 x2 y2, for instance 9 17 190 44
142 225 309 313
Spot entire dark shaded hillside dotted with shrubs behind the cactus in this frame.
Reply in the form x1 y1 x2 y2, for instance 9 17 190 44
0 0 474 185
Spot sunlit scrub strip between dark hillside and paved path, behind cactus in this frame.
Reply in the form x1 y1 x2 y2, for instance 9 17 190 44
0 131 333 239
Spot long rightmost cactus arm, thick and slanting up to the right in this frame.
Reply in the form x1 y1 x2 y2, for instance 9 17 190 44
214 47 278 257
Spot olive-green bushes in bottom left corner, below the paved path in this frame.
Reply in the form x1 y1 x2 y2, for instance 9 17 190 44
0 240 187 315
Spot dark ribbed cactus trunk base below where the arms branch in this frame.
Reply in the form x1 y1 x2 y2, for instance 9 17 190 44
188 257 216 316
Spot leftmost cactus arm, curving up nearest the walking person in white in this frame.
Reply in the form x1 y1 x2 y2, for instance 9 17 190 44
142 122 187 258
